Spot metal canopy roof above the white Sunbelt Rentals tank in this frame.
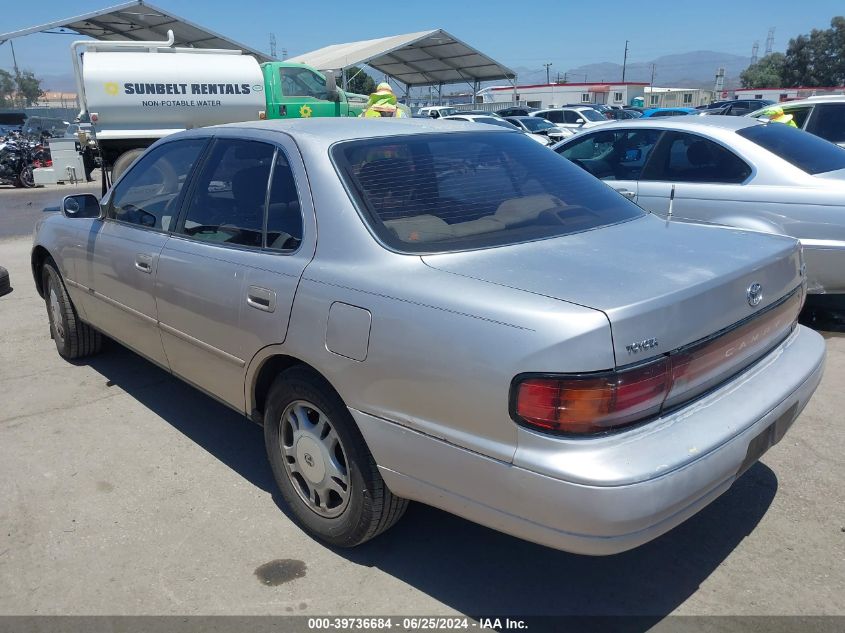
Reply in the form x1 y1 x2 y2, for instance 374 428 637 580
0 0 274 62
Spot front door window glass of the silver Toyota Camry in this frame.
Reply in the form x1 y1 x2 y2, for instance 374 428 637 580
108 139 207 231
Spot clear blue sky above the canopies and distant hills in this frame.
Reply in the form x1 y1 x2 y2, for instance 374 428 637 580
0 0 845 89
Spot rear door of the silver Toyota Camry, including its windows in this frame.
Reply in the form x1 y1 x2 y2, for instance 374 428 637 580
156 131 316 410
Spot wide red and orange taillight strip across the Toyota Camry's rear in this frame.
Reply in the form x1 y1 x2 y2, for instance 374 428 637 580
511 291 803 434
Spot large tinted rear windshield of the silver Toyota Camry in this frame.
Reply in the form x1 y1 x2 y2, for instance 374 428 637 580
332 132 644 253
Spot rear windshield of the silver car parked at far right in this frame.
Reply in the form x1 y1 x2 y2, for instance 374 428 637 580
736 123 845 174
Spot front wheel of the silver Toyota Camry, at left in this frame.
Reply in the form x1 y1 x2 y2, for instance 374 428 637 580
42 262 103 360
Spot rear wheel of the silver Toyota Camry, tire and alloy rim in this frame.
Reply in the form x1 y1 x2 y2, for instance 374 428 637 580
264 366 408 547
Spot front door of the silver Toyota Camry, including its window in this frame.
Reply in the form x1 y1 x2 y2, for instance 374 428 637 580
76 139 207 367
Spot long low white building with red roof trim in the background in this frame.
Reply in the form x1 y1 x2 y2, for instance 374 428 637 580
478 81 648 108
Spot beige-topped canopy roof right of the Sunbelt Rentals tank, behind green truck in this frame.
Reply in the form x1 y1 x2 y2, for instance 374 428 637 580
288 29 516 93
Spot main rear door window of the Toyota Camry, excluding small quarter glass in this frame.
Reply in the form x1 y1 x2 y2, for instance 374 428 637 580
178 139 275 248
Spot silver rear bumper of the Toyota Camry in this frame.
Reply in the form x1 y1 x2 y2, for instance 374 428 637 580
352 326 825 555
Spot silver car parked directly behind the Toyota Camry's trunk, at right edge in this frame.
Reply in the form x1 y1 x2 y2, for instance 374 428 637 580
553 117 845 307
